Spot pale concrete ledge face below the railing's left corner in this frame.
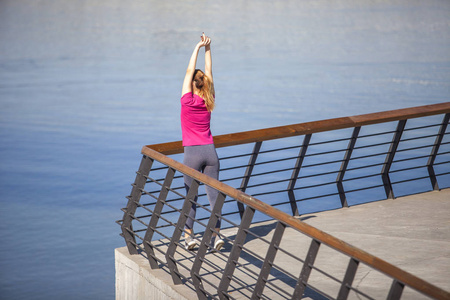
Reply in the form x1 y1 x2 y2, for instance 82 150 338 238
114 247 197 300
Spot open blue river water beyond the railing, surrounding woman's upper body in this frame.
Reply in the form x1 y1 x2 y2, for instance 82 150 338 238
0 0 450 299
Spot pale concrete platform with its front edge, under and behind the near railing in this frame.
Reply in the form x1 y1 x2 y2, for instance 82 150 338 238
116 189 450 299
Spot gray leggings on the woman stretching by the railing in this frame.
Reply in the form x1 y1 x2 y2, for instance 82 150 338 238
183 144 220 229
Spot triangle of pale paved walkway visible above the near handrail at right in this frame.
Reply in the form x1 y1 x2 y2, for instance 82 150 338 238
303 189 450 299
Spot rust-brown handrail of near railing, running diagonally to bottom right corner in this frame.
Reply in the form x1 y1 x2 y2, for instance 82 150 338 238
142 146 450 299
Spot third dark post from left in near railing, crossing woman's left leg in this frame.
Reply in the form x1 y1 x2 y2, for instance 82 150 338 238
166 179 199 284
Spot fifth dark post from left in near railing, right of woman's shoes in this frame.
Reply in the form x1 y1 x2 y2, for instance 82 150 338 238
217 206 255 299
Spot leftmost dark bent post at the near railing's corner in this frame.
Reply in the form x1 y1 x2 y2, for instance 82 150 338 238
121 155 153 254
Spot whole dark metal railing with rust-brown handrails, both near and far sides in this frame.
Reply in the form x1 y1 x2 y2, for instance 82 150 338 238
118 102 450 299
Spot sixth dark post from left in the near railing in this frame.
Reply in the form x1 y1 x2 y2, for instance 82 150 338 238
251 222 286 299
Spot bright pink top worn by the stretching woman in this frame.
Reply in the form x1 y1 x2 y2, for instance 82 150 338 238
181 93 214 146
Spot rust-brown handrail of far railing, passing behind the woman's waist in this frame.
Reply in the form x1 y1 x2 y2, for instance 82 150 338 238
142 102 450 155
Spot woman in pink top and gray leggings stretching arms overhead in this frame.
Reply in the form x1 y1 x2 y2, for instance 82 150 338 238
181 33 224 251
